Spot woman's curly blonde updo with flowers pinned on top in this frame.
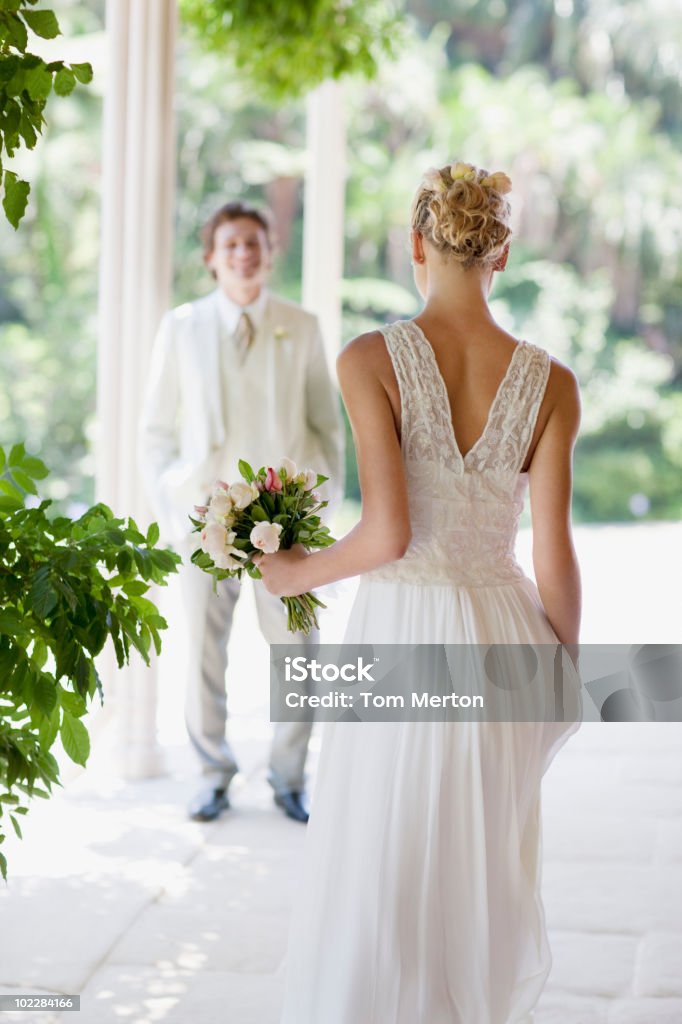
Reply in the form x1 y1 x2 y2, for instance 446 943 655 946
412 162 511 269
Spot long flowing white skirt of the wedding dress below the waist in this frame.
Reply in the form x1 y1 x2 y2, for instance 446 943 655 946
282 578 578 1024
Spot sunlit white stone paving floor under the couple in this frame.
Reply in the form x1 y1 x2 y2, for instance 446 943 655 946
0 524 682 1024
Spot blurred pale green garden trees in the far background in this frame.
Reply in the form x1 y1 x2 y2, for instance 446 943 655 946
0 0 682 521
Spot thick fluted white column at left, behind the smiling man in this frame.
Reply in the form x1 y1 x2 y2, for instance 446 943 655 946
96 0 176 778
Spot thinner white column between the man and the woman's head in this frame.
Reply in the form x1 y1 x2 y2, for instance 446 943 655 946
303 81 346 367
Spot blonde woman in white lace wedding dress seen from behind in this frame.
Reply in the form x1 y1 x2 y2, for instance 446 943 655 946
260 163 581 1024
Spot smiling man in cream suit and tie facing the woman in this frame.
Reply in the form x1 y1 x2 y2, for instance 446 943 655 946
139 202 343 822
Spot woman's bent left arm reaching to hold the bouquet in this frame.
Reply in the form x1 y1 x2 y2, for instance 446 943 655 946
258 331 411 597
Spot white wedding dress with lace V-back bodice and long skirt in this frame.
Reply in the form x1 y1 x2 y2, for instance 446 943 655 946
282 321 578 1024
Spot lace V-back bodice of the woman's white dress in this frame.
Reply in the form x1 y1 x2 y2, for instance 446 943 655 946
369 321 550 587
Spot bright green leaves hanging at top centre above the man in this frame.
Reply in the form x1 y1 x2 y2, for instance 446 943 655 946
180 0 402 101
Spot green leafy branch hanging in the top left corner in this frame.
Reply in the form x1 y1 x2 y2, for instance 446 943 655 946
0 0 92 228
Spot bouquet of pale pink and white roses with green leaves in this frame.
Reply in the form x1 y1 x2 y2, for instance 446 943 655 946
189 459 334 634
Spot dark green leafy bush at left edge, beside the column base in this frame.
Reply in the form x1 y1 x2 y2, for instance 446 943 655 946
0 444 180 878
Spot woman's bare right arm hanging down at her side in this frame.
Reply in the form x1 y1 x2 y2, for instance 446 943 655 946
528 364 582 645
